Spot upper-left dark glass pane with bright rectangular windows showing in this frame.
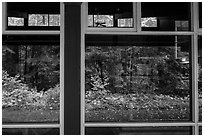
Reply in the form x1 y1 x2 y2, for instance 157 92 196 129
6 2 60 30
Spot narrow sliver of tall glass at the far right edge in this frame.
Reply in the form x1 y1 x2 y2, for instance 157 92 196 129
198 36 202 121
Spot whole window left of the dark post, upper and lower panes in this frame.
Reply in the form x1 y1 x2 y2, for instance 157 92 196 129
2 2 63 135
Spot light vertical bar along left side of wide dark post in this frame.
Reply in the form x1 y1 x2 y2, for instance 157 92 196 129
60 2 65 135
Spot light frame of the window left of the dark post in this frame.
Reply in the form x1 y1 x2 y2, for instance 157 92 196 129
2 2 64 135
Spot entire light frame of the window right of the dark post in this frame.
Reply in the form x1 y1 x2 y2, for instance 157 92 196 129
81 2 202 135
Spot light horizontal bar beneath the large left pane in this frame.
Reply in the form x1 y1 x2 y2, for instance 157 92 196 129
2 123 60 128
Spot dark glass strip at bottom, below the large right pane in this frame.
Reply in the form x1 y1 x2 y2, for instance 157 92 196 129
85 127 192 135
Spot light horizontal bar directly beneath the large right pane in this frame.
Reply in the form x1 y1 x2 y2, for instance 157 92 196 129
84 122 196 127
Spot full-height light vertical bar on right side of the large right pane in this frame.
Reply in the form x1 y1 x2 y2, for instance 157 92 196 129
191 2 199 135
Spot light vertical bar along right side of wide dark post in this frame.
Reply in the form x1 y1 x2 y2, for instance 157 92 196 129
81 3 88 135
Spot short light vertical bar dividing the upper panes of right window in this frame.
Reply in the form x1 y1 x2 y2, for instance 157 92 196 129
136 2 142 32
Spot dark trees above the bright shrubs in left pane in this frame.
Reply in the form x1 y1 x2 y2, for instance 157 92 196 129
2 45 60 91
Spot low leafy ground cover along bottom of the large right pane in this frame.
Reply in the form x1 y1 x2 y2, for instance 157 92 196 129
86 93 190 122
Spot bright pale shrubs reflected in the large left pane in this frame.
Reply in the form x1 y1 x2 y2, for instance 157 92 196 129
2 71 60 110
